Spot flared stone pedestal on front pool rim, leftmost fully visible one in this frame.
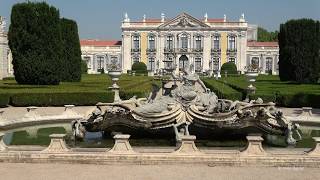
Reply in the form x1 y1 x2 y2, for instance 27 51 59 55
43 134 70 153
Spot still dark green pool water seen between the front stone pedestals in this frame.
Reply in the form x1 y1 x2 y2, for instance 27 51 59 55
4 127 320 148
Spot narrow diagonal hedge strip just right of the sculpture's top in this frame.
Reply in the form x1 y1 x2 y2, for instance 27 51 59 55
203 78 242 100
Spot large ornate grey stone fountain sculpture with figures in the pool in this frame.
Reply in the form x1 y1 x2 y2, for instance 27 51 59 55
73 68 301 145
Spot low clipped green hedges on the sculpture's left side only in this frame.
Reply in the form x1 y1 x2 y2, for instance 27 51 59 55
0 74 159 106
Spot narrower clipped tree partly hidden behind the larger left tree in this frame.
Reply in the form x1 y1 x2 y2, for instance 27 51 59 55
61 18 82 82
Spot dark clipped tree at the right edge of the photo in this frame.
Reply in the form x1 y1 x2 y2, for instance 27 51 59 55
279 19 320 83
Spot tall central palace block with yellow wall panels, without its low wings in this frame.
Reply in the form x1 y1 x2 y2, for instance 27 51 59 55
121 13 277 73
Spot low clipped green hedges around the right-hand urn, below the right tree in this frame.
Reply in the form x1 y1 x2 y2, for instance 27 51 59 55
218 75 320 108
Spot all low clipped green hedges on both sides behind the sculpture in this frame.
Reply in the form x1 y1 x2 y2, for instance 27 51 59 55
0 74 320 108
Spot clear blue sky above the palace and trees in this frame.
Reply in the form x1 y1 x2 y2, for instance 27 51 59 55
0 0 320 39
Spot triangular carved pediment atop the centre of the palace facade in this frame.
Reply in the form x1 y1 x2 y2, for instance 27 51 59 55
159 13 209 29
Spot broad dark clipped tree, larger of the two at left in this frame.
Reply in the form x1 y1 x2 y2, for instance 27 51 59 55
8 2 61 84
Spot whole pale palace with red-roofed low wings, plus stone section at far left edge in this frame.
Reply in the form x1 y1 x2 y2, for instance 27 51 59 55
0 13 279 79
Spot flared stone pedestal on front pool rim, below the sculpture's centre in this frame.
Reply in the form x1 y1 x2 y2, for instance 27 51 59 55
174 136 200 154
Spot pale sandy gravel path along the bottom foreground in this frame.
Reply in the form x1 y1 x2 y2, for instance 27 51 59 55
0 163 320 180
